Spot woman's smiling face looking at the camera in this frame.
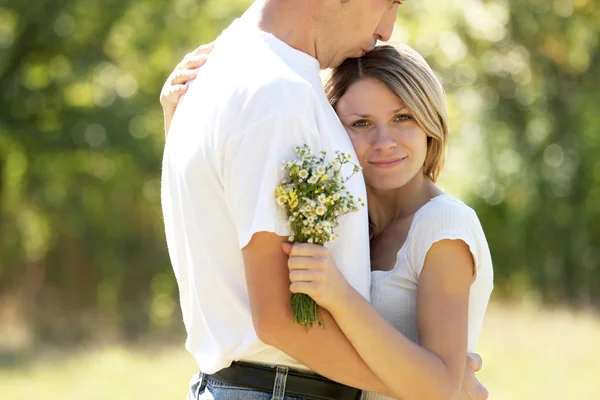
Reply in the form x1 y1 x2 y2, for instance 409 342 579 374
337 78 427 190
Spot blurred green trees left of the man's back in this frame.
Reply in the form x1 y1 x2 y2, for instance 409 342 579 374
0 0 247 341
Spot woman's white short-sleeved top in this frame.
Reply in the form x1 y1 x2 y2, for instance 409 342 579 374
362 194 493 400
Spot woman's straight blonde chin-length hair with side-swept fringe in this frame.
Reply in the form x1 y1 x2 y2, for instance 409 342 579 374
325 45 449 182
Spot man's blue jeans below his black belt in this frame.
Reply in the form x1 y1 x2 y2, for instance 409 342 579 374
187 366 304 400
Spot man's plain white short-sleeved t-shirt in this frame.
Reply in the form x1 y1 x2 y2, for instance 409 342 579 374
162 19 370 373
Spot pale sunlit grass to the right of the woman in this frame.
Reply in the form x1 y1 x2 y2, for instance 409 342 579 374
478 305 600 400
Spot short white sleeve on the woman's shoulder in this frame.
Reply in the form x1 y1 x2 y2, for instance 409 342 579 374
408 200 487 279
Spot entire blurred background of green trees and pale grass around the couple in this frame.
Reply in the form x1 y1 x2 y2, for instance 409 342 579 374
0 0 600 400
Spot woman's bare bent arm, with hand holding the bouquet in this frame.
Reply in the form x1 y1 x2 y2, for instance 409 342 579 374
289 240 474 400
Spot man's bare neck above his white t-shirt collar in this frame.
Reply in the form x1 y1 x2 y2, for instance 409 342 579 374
242 0 316 58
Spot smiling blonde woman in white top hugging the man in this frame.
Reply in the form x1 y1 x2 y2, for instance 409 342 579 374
163 45 493 399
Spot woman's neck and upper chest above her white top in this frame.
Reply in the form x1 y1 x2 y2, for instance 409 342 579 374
367 174 443 237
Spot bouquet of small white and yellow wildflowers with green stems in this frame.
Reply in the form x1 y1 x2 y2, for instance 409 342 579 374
275 144 364 327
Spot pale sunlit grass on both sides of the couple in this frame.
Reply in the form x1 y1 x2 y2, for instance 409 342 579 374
0 304 600 400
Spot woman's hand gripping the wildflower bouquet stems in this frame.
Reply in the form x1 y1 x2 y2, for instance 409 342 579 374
282 243 353 314
